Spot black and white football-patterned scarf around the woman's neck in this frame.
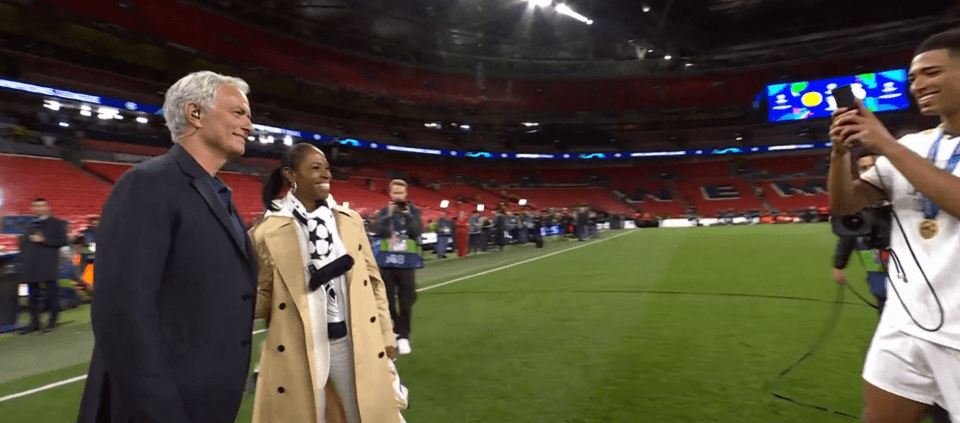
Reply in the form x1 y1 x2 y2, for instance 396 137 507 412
284 195 353 339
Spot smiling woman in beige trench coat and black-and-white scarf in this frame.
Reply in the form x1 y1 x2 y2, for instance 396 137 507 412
250 144 406 423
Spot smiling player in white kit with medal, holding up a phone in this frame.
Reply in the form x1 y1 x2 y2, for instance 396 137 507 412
828 30 960 423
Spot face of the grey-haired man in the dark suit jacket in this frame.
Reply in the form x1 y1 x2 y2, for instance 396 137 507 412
193 84 253 159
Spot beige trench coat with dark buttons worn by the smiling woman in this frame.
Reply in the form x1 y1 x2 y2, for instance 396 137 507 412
250 205 400 423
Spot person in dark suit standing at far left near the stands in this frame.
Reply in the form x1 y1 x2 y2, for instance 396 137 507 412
17 198 69 334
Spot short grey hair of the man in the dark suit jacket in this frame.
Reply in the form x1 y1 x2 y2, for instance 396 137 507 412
163 71 250 143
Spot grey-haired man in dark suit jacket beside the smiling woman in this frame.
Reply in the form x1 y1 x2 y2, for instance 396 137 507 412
77 71 258 423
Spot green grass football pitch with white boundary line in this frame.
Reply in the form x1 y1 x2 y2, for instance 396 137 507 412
0 225 908 423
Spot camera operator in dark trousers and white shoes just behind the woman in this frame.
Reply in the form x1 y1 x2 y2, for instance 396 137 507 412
377 179 423 354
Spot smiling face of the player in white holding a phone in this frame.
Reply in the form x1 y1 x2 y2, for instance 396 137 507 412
909 49 960 118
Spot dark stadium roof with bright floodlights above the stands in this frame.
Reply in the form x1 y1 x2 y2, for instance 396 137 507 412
193 0 960 77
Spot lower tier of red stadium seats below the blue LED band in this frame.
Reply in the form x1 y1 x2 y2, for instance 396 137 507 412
0 146 829 255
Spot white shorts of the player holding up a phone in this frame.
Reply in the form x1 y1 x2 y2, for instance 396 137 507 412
863 324 960 422
